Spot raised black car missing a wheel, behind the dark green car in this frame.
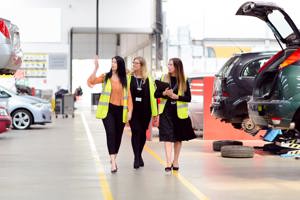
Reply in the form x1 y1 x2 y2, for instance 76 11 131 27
210 52 275 134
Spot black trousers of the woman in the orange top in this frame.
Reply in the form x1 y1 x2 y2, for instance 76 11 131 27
102 104 125 154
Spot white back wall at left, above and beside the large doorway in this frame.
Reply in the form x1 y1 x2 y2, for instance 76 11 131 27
0 0 155 93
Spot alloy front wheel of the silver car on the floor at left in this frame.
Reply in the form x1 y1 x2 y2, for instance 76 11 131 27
12 109 32 130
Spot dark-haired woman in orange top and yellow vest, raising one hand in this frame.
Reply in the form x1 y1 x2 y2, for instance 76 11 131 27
87 56 132 173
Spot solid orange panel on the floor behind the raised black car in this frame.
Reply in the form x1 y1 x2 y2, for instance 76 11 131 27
203 77 265 140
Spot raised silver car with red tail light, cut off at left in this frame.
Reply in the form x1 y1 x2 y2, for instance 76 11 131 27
0 18 22 75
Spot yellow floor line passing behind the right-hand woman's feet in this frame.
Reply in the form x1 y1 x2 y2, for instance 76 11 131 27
127 132 209 200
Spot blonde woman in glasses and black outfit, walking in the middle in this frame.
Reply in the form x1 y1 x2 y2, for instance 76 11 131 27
129 57 158 169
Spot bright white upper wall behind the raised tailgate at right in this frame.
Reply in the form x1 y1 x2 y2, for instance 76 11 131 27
164 0 300 39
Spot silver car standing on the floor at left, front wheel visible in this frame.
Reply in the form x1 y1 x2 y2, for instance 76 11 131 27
0 86 52 129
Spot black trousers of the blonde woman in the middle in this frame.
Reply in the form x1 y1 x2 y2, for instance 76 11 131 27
129 117 148 159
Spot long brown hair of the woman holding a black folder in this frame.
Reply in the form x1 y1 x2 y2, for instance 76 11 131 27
169 58 187 92
